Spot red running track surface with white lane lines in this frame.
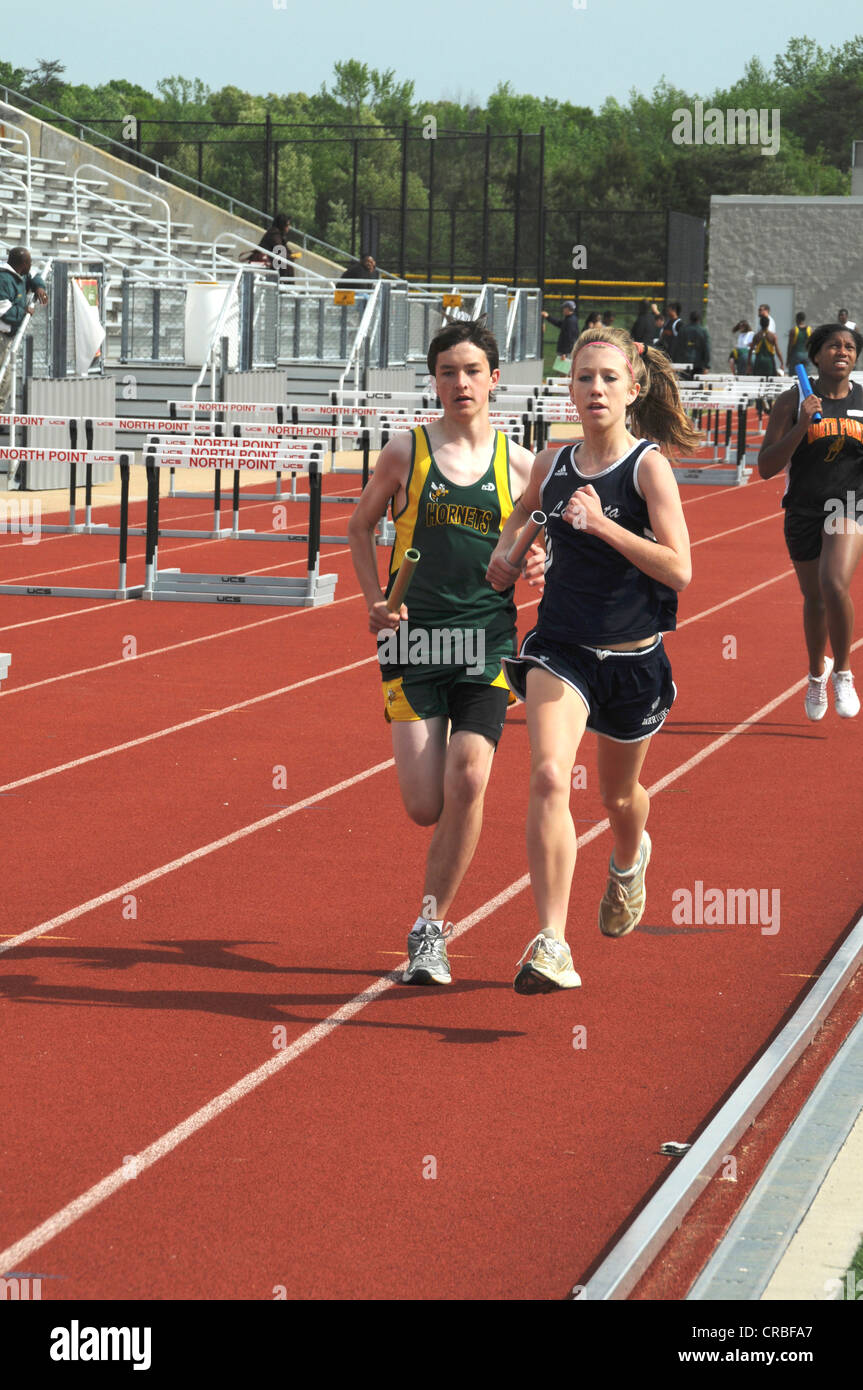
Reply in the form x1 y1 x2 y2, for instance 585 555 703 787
0 458 863 1300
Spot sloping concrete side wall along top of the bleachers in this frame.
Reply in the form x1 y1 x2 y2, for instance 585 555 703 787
0 104 342 275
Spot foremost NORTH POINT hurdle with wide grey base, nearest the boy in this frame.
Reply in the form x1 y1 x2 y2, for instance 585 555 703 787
140 439 338 607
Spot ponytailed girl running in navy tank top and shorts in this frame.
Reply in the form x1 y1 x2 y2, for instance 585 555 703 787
488 328 698 994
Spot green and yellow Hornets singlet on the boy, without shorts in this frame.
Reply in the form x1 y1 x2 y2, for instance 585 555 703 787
386 425 516 655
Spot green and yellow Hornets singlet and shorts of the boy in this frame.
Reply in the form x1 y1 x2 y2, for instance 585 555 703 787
378 425 516 744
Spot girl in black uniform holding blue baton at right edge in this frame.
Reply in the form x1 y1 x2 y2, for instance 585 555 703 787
759 324 863 720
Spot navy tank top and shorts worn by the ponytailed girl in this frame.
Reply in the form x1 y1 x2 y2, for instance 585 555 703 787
504 439 677 744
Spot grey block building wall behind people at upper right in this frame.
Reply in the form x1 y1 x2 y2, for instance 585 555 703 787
707 195 863 358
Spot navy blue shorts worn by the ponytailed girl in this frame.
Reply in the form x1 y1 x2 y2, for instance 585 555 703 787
503 628 677 744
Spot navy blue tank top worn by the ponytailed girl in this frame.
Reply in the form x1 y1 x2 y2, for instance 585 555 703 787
536 439 677 646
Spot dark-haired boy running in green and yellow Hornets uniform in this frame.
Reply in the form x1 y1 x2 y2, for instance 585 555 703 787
347 320 545 984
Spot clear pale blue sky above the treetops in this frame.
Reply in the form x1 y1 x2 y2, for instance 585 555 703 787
6 0 863 108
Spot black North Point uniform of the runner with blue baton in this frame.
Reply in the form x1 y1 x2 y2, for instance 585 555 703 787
782 381 863 560
